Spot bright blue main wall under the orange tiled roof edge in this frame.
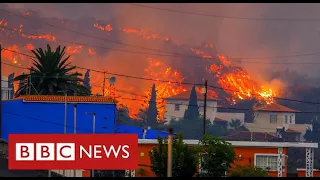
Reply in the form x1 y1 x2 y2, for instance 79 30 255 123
1 100 115 140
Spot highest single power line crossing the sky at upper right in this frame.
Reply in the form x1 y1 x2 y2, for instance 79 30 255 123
127 3 320 22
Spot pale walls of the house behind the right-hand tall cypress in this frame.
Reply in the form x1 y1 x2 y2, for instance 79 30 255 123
164 100 218 122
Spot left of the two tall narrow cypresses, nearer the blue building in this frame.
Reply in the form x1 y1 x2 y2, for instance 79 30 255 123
146 84 158 127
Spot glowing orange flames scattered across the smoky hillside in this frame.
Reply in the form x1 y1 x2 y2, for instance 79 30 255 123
0 15 275 120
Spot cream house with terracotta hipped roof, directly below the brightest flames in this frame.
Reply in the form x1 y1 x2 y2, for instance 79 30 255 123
245 103 312 141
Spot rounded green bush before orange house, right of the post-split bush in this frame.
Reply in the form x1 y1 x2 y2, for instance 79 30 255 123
199 134 235 177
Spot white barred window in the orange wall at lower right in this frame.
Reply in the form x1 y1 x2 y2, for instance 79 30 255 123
255 155 278 171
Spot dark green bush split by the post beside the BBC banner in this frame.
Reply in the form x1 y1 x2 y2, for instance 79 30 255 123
149 134 198 177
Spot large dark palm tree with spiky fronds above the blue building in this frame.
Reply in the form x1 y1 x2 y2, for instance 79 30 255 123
14 45 90 97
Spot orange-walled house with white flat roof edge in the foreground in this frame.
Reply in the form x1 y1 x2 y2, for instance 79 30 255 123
119 139 318 177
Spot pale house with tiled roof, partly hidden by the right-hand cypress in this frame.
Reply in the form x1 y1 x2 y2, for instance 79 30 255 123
164 91 218 122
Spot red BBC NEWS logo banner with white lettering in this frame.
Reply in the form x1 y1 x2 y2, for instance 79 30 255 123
8 134 138 170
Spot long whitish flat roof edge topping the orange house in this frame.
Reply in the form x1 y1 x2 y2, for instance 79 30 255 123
138 139 318 148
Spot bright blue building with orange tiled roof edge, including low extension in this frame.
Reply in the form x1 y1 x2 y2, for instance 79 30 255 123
1 96 167 140
